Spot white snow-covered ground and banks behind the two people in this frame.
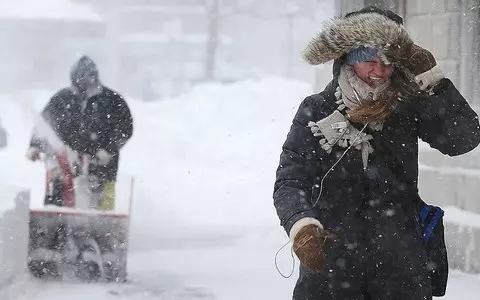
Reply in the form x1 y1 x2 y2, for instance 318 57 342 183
0 78 480 300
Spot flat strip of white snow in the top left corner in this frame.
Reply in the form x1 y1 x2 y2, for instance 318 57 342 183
0 0 102 21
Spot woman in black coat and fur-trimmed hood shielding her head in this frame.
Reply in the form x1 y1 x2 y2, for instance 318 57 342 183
274 7 480 300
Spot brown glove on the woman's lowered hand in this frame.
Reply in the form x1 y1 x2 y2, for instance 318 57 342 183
293 224 335 272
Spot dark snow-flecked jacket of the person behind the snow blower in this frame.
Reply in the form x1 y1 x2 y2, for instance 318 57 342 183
31 86 133 180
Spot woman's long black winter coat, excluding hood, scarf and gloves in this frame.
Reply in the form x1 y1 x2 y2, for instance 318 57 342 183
274 79 480 299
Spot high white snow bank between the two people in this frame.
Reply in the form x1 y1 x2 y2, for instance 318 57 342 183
120 78 309 239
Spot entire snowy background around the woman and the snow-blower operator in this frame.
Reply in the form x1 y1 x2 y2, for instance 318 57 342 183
0 0 480 300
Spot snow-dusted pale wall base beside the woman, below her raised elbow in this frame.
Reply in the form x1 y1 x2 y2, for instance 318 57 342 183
419 166 480 273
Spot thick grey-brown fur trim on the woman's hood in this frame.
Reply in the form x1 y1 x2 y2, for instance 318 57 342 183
303 13 413 65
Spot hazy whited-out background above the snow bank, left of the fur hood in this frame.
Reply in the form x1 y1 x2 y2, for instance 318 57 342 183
0 0 333 100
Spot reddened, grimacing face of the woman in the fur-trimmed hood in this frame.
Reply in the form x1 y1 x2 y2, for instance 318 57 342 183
353 57 393 88
